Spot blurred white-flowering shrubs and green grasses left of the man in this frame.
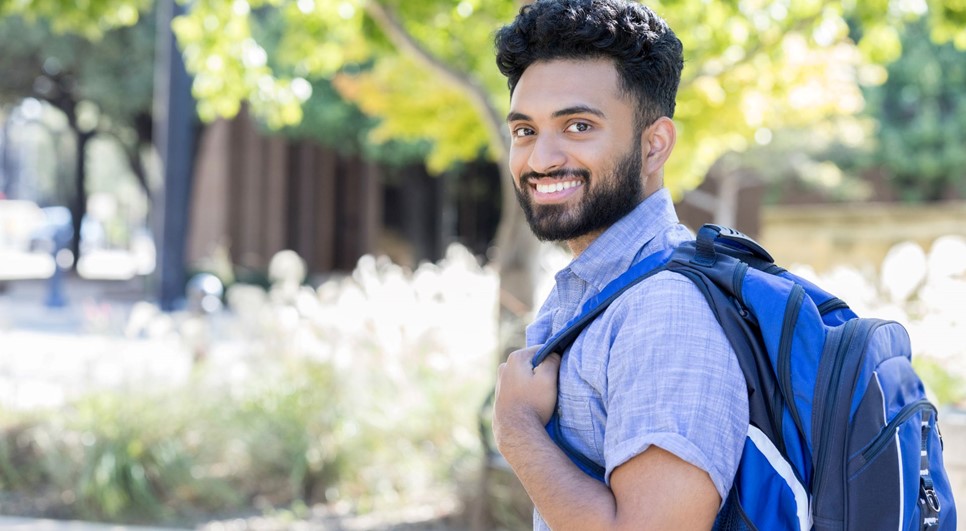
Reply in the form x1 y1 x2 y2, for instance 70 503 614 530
0 247 497 522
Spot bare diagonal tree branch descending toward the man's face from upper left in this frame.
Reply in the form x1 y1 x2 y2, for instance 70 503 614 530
365 0 510 160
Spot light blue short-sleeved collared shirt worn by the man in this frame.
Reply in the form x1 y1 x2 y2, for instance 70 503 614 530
527 189 748 529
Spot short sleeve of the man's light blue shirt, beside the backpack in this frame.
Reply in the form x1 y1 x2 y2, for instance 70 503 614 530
603 272 748 501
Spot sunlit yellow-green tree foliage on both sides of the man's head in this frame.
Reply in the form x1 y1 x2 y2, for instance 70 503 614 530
7 0 966 306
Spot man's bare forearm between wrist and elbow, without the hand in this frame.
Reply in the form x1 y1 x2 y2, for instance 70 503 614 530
500 423 617 530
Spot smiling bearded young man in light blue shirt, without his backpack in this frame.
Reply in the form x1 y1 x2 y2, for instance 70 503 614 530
493 0 748 530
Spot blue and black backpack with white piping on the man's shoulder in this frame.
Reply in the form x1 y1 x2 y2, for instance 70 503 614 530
533 225 956 531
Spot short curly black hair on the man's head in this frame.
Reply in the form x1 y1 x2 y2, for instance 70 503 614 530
495 0 684 128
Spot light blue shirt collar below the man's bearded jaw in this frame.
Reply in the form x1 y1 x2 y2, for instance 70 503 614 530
567 188 678 291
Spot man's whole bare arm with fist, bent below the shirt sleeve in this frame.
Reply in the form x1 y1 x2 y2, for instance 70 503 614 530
493 347 721 531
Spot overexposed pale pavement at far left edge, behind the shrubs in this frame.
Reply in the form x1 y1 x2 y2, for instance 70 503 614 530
0 278 191 409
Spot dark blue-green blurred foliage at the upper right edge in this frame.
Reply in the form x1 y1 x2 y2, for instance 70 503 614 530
867 22 966 201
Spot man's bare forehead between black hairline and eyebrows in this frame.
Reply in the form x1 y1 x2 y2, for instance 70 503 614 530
510 59 632 117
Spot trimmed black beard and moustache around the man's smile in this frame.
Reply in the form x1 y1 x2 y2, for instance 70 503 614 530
513 141 644 241
